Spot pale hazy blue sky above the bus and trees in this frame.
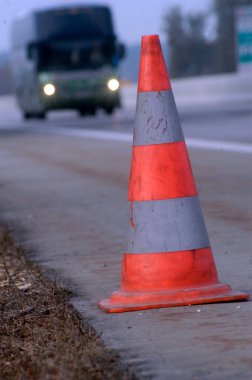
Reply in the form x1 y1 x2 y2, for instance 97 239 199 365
0 0 211 51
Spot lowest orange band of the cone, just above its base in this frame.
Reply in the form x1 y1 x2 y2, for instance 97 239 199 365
122 248 218 291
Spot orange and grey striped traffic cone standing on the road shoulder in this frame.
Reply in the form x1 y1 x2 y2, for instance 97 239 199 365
98 35 249 313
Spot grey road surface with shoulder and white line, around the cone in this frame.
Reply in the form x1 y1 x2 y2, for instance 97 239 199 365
0 96 252 380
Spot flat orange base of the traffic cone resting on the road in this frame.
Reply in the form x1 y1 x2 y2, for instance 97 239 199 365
98 284 249 313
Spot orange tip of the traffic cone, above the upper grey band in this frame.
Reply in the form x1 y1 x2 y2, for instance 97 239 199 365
138 35 171 92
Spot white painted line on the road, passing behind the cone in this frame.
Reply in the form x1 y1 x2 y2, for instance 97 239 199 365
52 128 252 154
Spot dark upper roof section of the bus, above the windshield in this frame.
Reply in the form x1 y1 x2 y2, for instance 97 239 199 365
11 4 114 47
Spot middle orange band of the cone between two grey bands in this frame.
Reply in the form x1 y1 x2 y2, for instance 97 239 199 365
128 141 197 201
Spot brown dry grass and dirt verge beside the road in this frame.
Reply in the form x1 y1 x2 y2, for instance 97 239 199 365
0 227 135 380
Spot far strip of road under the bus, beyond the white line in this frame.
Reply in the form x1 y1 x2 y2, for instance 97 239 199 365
0 99 252 143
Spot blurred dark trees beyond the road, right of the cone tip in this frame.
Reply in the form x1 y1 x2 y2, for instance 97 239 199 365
164 0 252 77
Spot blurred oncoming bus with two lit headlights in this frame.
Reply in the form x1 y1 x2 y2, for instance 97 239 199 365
10 6 125 119
